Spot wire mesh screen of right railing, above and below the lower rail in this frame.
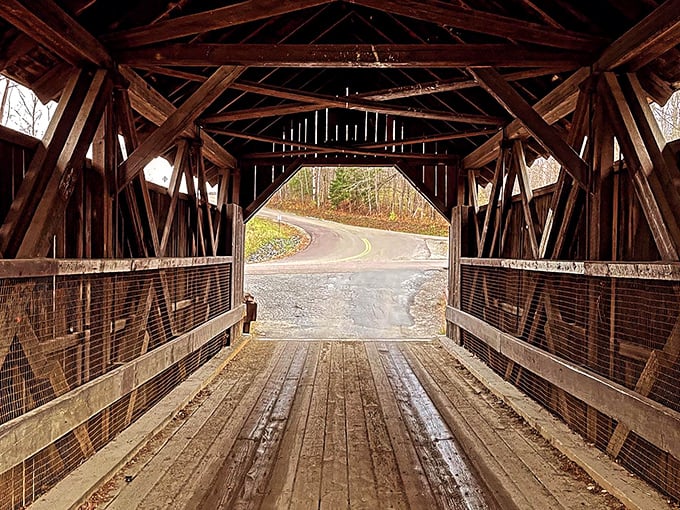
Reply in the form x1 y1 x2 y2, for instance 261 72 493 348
461 265 680 499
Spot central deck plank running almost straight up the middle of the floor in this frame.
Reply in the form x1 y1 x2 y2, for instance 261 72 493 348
319 342 349 510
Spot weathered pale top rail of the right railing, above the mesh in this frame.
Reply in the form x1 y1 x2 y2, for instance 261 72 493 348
461 257 680 281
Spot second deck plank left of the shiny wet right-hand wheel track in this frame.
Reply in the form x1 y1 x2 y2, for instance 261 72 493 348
352 343 409 509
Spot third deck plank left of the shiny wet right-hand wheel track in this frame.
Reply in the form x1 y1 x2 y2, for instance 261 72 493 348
341 342 380 510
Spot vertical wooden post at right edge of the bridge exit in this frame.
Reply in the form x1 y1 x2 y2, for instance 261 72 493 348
446 205 472 345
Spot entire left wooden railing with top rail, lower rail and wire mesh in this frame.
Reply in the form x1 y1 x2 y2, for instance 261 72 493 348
0 257 244 507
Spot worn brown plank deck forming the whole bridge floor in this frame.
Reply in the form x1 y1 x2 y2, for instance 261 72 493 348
97 341 612 510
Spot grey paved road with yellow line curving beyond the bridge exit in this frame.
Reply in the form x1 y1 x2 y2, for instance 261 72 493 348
245 211 447 340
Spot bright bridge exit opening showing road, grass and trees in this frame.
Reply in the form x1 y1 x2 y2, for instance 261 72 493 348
244 166 448 340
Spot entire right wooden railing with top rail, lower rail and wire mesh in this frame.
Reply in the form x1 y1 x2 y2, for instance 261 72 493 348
446 258 680 498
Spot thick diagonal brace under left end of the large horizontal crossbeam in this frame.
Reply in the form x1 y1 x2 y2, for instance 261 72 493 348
118 66 245 188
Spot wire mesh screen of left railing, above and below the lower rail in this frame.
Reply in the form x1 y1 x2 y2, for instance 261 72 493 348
0 263 231 509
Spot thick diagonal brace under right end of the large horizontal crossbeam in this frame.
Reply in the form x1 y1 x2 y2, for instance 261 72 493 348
473 69 589 189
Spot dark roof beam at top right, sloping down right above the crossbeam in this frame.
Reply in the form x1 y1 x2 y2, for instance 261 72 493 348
351 0 606 51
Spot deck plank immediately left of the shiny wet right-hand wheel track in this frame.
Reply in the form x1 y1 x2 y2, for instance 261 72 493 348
365 343 436 509
